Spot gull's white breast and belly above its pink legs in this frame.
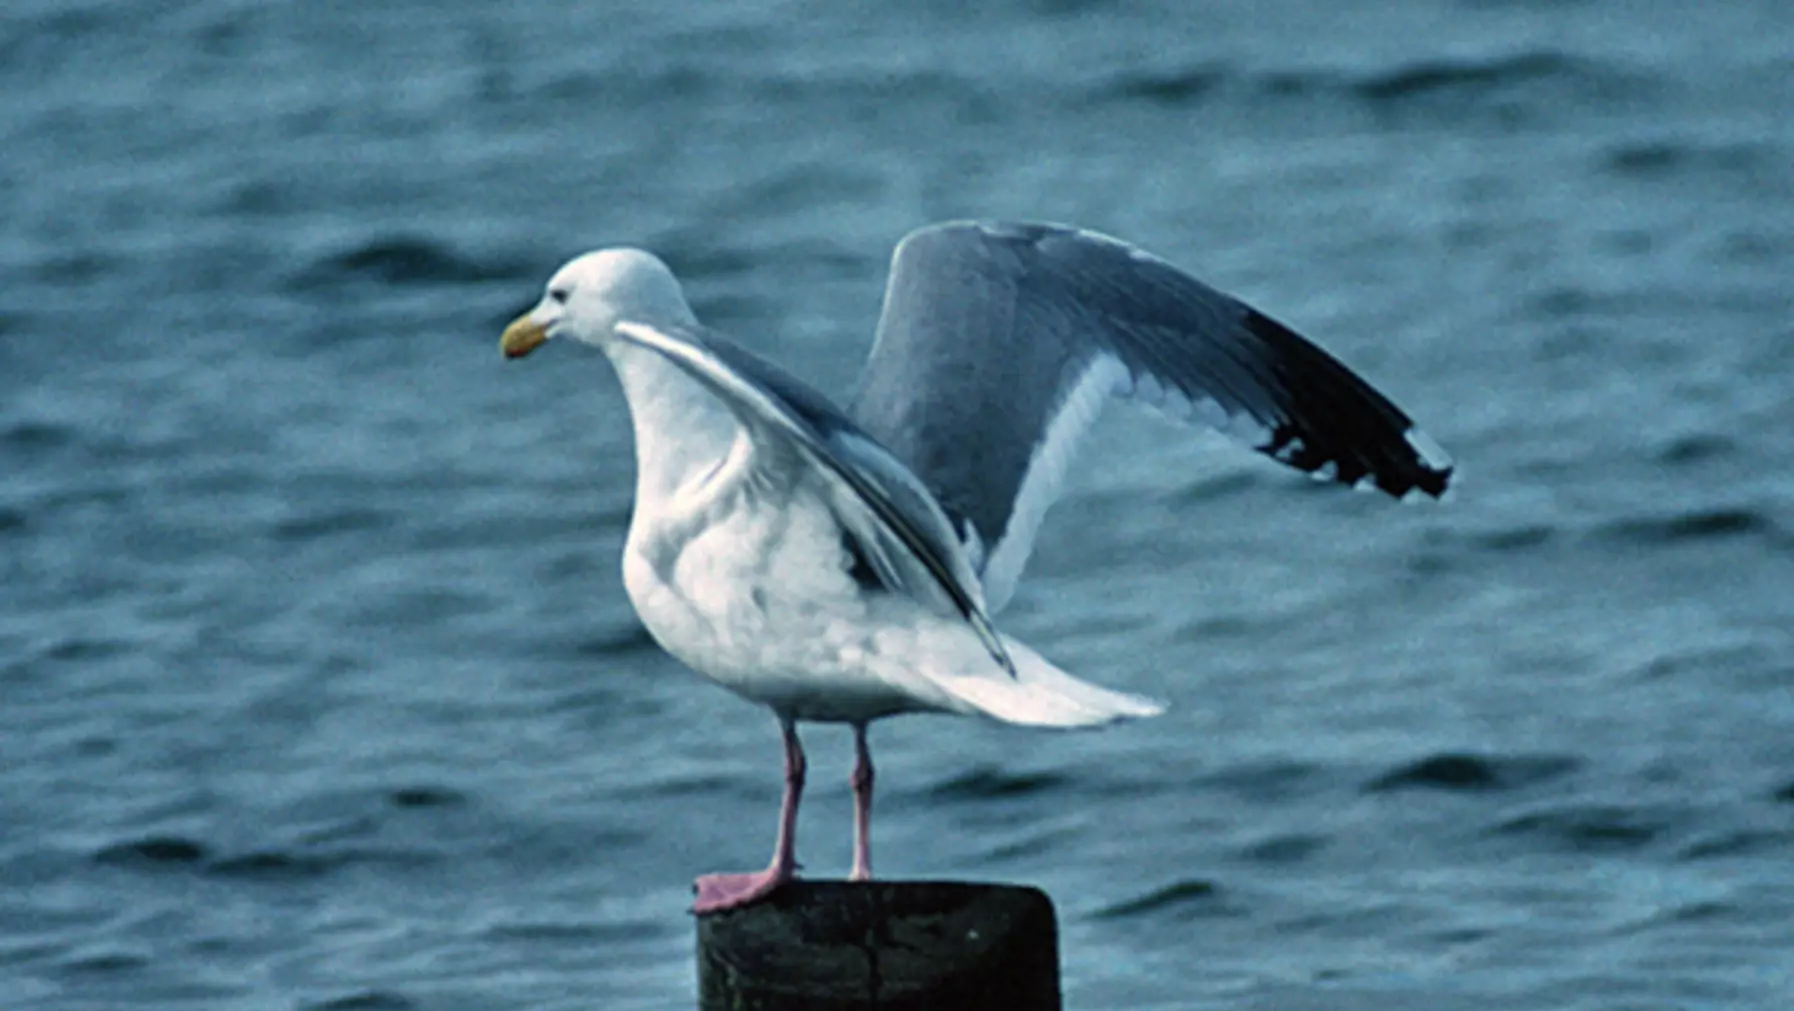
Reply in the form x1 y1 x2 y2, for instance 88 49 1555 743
623 461 983 722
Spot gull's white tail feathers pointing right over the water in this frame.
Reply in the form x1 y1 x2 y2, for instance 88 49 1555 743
929 636 1164 728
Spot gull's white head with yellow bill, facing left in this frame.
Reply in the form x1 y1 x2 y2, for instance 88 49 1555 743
499 246 696 359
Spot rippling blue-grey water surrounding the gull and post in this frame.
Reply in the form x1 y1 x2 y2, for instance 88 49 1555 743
0 0 1794 1011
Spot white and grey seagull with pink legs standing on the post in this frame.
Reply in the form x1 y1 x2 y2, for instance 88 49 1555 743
499 220 1453 914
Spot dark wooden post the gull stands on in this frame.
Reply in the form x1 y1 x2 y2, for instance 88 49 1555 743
698 880 1060 1011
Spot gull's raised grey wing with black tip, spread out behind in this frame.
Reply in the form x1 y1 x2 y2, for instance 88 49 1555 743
850 222 1451 611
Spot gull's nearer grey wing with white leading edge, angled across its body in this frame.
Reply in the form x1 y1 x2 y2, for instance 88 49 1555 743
617 323 1015 676
